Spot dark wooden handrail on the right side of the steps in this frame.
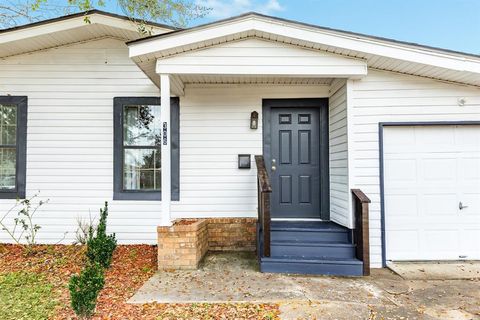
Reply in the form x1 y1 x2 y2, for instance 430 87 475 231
352 189 371 276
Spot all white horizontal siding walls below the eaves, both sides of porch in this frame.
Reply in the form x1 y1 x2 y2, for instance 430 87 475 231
0 35 480 267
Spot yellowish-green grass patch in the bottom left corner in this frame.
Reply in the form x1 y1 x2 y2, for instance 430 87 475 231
0 271 56 320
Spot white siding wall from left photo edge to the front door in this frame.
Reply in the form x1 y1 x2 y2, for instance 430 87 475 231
0 39 329 243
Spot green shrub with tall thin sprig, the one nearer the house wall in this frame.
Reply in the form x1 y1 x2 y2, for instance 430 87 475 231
87 202 117 268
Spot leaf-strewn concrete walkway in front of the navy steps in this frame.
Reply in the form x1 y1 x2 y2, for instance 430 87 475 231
129 253 480 319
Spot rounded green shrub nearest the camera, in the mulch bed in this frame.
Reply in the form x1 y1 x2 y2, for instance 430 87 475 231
68 263 105 319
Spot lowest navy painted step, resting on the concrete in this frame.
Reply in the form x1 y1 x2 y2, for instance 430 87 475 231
260 257 363 276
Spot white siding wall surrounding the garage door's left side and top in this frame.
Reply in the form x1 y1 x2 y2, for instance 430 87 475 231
348 70 480 267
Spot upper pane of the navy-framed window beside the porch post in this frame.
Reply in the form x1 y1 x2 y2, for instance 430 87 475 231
123 106 161 146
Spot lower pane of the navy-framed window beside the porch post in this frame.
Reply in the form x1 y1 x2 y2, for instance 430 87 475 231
123 149 161 190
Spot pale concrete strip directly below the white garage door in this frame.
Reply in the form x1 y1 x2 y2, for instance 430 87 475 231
387 261 480 280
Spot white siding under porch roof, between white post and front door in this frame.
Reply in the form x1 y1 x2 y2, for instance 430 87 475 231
172 85 329 218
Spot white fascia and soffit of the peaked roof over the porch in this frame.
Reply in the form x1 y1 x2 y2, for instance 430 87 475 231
127 13 480 86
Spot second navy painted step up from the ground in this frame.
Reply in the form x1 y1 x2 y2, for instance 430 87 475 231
270 240 355 259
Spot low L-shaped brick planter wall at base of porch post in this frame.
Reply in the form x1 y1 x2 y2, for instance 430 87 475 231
157 218 257 270
